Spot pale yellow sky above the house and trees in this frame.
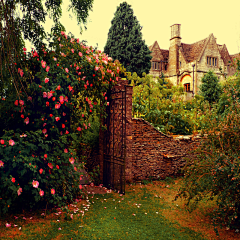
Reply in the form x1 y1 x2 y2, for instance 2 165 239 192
23 0 240 54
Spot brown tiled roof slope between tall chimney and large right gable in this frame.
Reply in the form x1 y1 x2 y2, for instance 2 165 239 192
181 38 207 62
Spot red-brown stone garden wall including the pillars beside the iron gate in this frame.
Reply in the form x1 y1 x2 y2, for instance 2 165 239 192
99 80 200 182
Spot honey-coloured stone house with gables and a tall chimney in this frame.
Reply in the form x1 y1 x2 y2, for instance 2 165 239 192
149 24 240 99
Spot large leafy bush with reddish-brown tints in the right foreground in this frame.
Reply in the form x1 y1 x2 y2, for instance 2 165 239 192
176 103 240 235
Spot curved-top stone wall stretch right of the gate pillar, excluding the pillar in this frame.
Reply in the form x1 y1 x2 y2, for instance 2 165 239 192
129 118 200 181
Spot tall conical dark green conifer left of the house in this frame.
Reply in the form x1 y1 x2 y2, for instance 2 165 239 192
104 2 152 77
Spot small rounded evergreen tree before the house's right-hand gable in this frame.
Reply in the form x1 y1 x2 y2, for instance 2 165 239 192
199 70 222 104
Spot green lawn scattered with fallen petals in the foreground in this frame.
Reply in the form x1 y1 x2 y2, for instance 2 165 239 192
0 177 210 240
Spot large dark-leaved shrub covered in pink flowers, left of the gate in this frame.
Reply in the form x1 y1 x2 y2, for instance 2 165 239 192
0 32 122 213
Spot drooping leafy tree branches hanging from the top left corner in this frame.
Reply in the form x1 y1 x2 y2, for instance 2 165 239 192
0 0 93 96
